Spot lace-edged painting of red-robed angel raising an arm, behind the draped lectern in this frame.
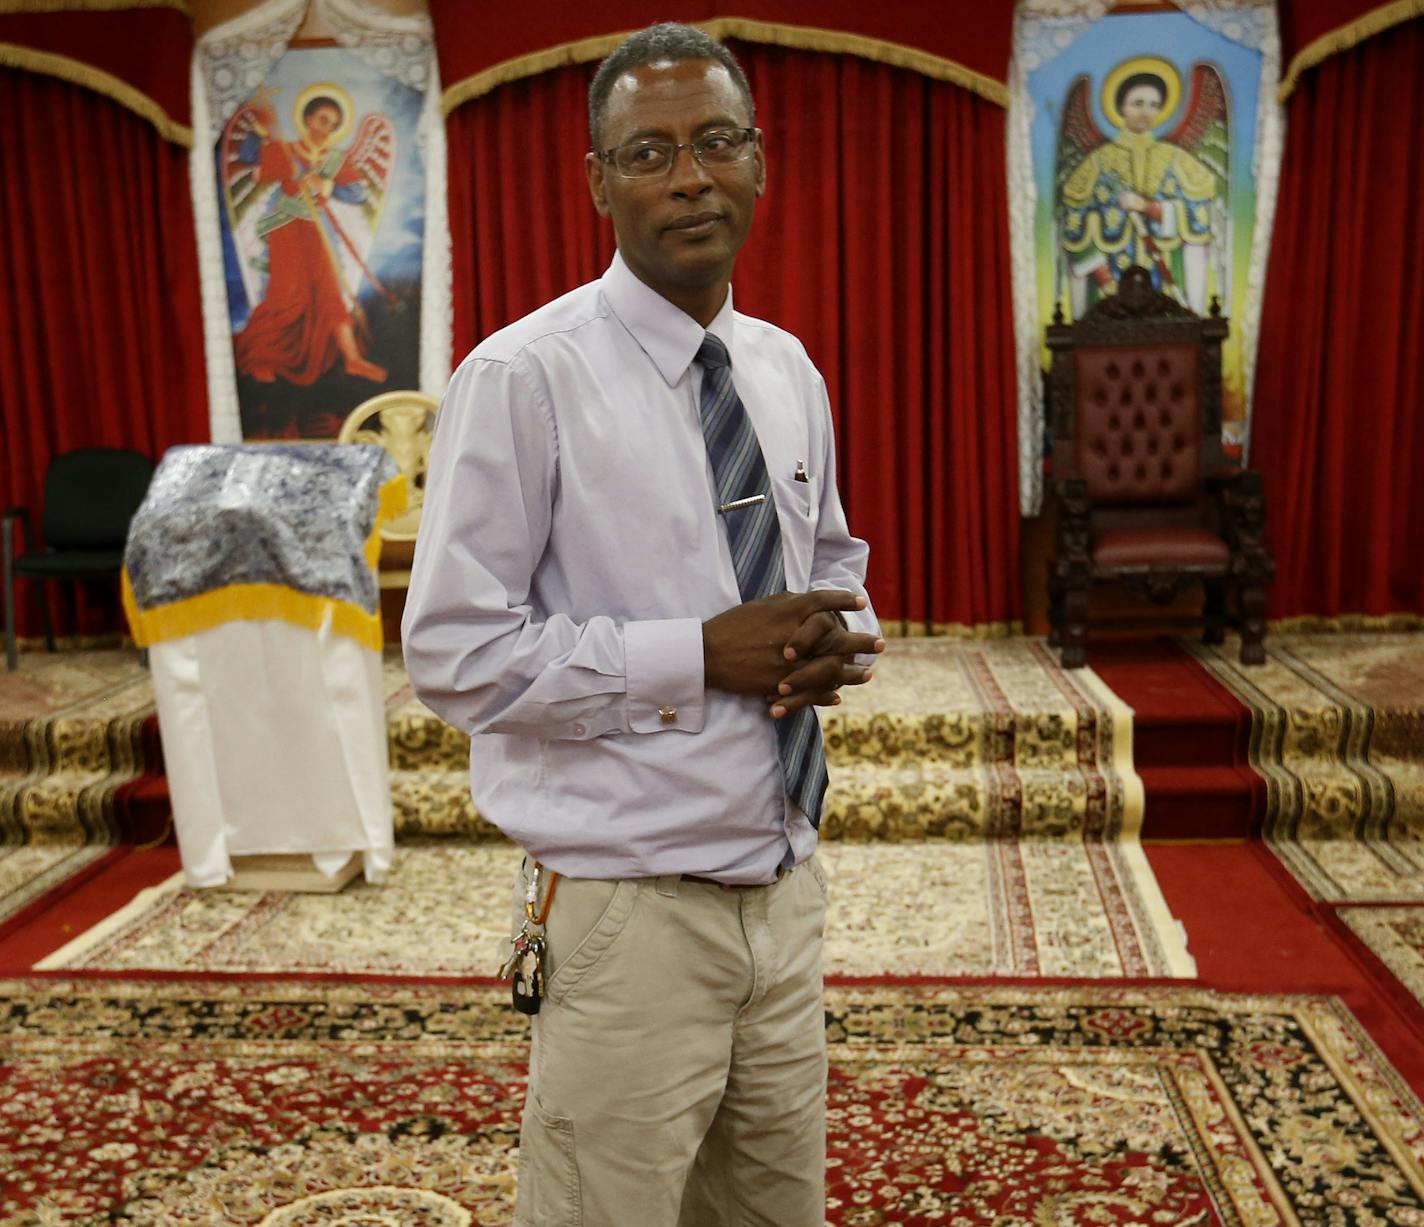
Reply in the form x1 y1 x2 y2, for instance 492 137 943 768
189 0 443 441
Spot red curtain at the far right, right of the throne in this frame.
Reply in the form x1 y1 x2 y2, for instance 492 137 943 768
1252 20 1424 618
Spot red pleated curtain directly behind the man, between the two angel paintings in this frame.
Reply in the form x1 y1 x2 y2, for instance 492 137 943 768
449 44 1021 626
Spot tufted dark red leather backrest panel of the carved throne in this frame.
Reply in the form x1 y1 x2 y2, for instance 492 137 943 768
1074 344 1202 504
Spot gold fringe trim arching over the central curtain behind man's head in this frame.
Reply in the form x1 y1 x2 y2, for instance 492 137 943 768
440 17 1008 115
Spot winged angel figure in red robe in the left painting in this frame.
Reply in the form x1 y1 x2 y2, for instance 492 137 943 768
221 83 396 387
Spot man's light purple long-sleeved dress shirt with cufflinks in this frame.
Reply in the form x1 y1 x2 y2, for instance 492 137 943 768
403 256 879 883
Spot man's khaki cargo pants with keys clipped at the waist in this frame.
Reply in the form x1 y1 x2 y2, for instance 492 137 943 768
515 860 826 1227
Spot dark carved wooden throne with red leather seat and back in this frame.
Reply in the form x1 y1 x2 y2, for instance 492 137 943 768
1048 269 1276 669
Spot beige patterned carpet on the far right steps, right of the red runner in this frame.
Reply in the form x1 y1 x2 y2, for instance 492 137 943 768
1186 632 1424 902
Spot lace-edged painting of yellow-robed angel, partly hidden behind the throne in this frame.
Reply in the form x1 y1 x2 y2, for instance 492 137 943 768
1010 0 1280 512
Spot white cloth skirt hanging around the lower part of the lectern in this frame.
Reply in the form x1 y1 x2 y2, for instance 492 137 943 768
150 621 394 887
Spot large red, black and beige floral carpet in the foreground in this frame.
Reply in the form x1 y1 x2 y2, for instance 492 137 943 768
0 979 1424 1227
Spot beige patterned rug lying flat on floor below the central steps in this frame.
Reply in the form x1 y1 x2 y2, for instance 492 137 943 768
38 841 1193 978
